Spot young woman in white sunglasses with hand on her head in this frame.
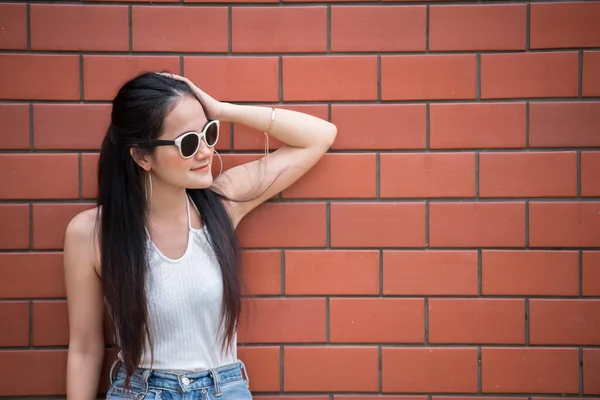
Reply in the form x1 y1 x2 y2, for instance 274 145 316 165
64 73 336 400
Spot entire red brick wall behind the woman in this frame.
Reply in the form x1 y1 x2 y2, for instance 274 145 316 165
0 0 600 400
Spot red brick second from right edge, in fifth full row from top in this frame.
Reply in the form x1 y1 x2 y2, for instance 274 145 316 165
429 202 525 247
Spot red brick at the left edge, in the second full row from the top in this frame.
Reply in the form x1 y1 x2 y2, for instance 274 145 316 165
0 54 79 100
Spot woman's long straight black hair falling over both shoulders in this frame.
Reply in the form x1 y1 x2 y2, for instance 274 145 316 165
96 72 248 386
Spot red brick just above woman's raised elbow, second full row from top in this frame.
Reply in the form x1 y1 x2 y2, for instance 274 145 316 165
283 56 377 101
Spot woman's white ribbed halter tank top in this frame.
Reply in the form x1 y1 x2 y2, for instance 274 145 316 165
119 196 237 372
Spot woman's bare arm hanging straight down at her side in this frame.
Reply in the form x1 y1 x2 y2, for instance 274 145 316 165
64 212 104 400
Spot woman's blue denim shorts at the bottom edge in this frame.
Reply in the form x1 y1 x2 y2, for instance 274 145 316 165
106 359 252 400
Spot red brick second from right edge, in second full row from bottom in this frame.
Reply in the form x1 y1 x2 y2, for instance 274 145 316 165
429 299 525 344
